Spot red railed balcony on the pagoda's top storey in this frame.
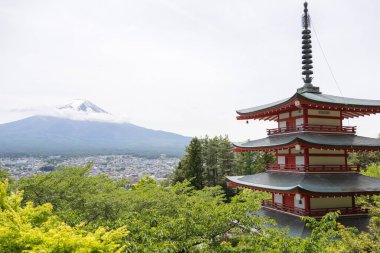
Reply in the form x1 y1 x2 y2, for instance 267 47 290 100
267 124 356 135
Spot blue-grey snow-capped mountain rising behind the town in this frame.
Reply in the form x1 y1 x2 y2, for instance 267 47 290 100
0 99 190 156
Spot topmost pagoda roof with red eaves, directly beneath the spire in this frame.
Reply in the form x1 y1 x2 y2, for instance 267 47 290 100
236 92 380 120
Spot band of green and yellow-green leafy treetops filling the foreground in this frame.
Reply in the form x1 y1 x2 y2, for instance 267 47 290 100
12 165 380 253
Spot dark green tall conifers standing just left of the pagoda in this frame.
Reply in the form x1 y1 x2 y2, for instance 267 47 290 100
173 136 275 195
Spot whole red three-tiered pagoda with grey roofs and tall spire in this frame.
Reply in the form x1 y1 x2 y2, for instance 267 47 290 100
227 2 380 217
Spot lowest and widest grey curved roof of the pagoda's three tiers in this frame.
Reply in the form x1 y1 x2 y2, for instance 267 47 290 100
227 171 380 194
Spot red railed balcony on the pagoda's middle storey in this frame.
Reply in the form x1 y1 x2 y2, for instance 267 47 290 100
266 164 360 173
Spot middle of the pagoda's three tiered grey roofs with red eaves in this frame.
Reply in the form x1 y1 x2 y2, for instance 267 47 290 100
233 133 380 152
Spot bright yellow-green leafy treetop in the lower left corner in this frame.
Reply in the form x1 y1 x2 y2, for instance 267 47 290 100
0 181 128 253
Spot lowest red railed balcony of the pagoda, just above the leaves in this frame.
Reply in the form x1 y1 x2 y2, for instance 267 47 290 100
262 199 368 217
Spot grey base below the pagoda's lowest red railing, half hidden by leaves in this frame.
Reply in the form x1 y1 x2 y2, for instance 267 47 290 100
256 207 370 237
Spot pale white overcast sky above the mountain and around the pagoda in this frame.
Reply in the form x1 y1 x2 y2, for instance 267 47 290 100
0 0 380 141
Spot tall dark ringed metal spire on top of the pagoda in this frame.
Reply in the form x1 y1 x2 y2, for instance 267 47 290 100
297 1 320 93
